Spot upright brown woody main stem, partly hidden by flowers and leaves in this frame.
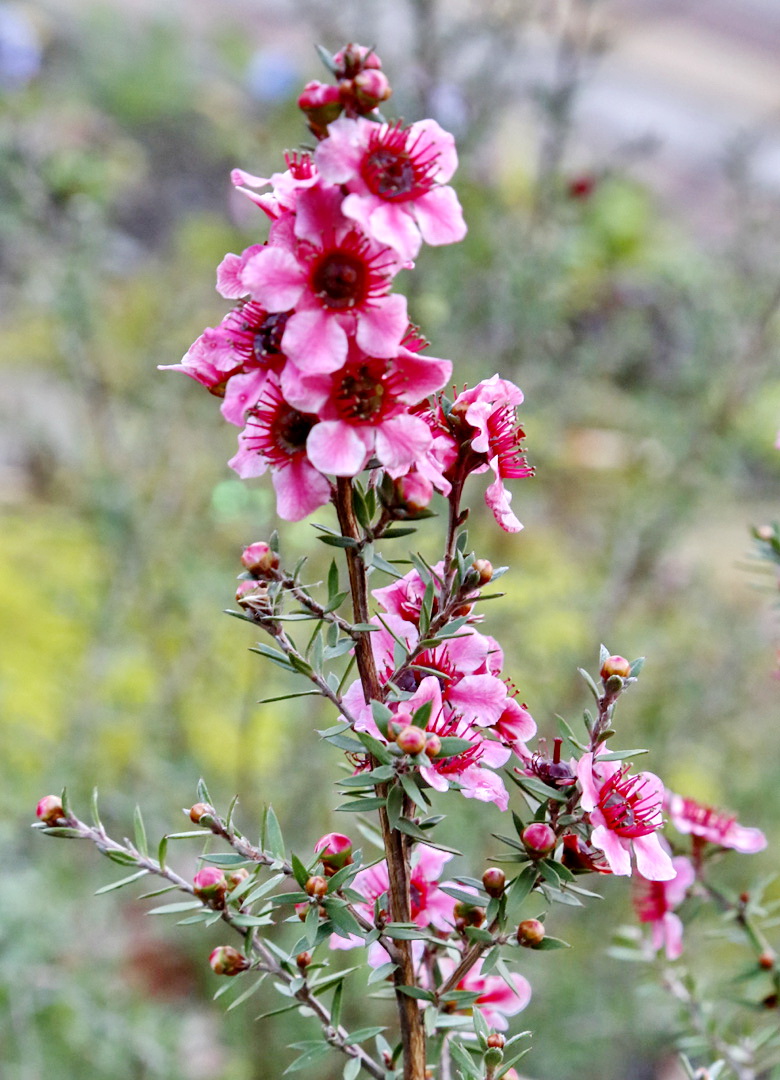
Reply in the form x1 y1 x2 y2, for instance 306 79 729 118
336 476 426 1080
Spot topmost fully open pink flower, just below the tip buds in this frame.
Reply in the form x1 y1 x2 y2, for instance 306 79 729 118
315 118 466 261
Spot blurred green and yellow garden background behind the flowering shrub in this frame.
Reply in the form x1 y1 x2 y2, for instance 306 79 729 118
0 0 780 1080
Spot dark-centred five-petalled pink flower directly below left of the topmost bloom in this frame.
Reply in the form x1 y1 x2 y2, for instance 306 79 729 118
241 187 408 373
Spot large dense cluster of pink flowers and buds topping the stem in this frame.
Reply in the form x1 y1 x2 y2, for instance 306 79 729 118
160 53 530 530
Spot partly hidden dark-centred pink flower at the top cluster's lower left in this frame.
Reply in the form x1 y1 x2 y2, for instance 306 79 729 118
228 377 331 522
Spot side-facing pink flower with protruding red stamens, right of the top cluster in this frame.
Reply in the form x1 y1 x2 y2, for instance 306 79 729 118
448 375 534 532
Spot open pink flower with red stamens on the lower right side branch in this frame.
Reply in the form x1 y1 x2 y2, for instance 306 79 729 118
577 753 674 881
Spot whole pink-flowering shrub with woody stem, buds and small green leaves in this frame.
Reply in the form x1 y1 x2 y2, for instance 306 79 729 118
38 45 780 1080
